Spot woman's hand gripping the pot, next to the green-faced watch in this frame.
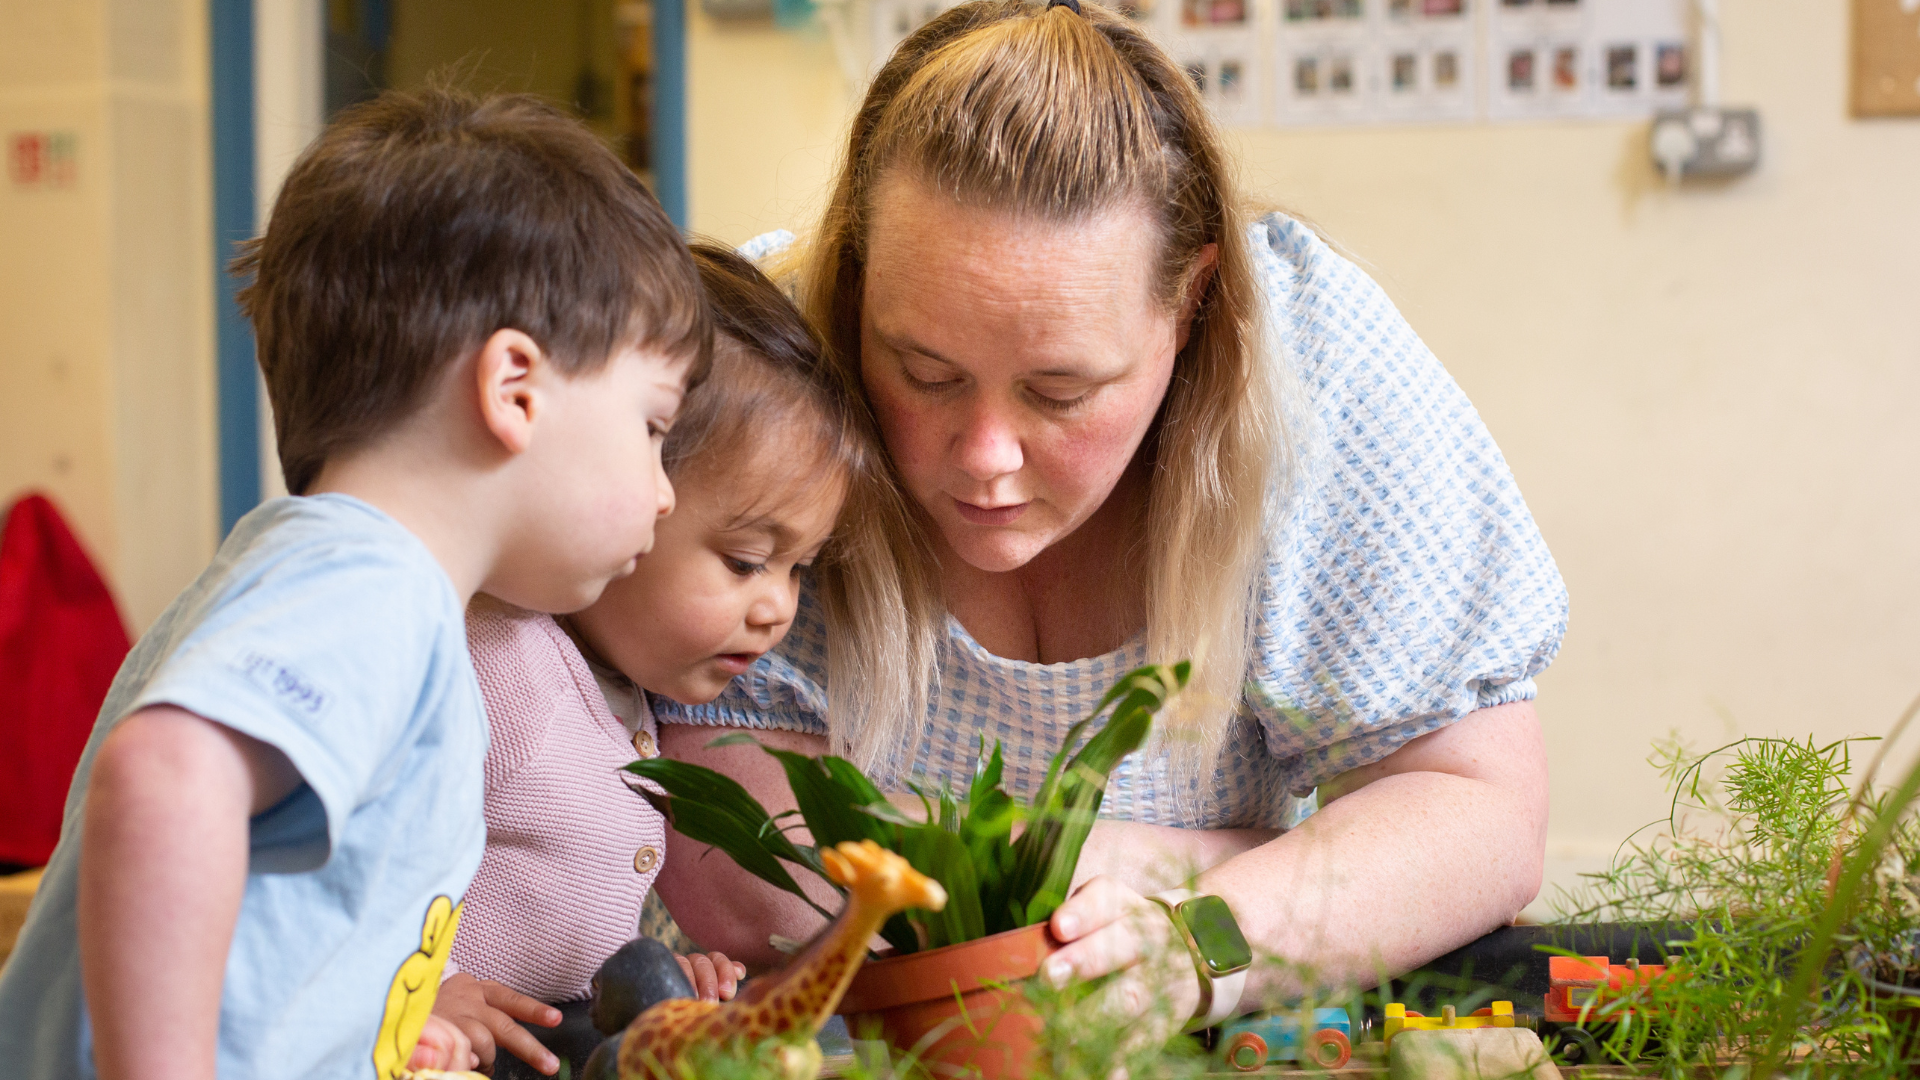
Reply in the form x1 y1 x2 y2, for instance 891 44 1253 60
1043 876 1200 1040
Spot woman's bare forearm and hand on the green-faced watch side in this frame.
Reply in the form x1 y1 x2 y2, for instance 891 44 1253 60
1054 701 1548 1005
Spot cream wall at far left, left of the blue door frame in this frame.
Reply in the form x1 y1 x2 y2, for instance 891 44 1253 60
0 0 217 632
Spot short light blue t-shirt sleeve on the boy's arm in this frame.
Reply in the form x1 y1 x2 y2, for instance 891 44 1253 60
129 540 465 872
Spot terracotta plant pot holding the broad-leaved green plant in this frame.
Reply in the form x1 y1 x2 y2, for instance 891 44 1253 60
839 922 1060 1080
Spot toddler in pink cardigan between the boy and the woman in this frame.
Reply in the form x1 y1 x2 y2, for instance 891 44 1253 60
436 244 868 1076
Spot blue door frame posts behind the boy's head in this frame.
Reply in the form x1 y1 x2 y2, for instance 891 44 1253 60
207 0 687 538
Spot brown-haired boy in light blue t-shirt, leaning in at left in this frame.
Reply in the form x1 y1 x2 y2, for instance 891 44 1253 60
0 92 712 1080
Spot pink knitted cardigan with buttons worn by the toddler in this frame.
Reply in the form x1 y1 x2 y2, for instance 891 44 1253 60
447 598 666 1001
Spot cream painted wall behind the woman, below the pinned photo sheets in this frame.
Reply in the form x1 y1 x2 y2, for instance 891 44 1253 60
689 0 1920 911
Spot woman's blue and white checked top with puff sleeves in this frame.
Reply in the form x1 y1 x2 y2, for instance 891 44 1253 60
657 215 1567 828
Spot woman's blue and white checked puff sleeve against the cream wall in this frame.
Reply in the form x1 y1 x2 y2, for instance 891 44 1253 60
1250 215 1567 792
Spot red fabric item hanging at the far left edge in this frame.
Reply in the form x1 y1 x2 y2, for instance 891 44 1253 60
0 494 131 867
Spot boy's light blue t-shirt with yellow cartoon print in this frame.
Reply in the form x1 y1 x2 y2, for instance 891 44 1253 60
0 494 488 1080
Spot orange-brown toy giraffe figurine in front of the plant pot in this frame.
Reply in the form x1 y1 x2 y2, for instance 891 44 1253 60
620 840 947 1080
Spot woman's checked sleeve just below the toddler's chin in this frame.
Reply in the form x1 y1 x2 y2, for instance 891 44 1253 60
651 582 828 736
